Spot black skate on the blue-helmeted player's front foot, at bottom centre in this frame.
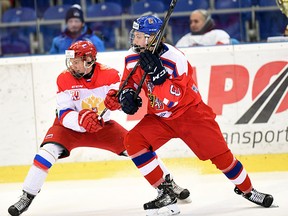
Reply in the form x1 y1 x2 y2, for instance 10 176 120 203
143 175 180 216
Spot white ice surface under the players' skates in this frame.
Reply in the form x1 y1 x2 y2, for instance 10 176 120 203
0 170 288 216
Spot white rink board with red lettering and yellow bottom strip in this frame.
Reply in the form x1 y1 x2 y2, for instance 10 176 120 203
0 43 288 182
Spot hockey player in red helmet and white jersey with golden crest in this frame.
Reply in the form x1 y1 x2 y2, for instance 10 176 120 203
8 41 189 216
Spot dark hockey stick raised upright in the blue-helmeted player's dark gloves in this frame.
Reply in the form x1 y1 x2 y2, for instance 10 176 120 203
134 0 177 100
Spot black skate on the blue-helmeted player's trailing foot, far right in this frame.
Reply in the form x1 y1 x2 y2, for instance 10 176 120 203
234 187 273 208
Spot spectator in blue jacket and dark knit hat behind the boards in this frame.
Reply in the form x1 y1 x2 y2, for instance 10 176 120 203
49 4 105 54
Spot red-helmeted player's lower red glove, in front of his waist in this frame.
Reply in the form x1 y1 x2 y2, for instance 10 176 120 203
78 109 104 133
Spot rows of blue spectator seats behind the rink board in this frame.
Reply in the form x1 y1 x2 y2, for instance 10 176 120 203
0 0 288 56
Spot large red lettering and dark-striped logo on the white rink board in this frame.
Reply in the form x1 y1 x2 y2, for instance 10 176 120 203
128 61 288 124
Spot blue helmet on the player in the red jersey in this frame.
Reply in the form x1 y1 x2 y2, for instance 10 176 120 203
132 15 163 35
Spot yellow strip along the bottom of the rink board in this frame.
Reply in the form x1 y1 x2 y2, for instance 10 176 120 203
0 154 288 183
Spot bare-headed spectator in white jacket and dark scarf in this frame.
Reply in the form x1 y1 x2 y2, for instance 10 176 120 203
175 9 230 47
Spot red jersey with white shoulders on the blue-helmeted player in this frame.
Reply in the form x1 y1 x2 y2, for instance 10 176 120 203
121 44 201 119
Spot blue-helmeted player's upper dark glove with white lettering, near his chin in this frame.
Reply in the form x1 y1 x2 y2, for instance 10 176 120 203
140 50 168 85
